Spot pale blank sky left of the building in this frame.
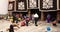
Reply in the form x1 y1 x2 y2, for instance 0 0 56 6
0 0 8 15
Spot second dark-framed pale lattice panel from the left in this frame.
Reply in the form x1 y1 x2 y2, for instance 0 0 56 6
16 0 27 11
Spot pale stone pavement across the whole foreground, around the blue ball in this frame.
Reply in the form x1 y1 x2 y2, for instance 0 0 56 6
0 20 60 32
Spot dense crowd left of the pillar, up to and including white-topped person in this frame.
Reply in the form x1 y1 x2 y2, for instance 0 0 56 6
8 13 39 26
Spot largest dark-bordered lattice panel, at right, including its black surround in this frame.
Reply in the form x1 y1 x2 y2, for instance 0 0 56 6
40 0 57 10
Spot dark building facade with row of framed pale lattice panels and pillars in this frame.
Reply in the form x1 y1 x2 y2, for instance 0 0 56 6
8 0 60 21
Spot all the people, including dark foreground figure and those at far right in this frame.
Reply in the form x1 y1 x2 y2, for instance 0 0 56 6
3 13 57 32
